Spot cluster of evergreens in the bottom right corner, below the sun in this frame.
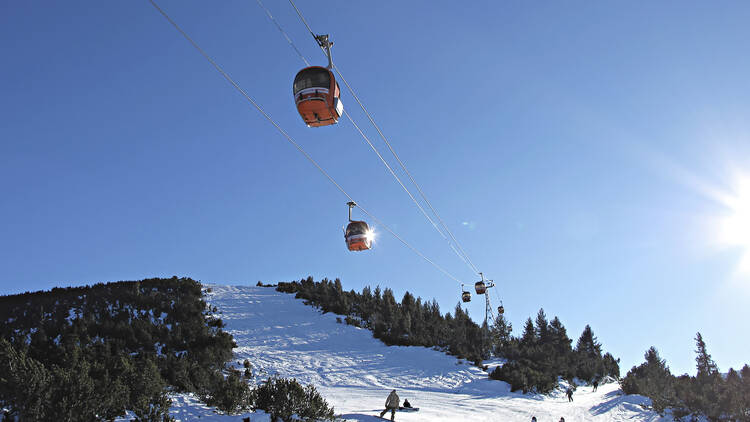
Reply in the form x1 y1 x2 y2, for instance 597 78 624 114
620 333 750 422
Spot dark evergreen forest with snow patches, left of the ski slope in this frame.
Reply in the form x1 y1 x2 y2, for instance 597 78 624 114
0 277 333 422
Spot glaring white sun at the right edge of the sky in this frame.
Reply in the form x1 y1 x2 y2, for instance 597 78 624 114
718 176 750 274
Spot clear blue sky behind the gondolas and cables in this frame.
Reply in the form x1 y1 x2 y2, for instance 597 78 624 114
0 0 750 374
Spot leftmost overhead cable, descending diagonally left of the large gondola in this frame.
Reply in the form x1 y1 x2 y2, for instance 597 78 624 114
148 0 460 282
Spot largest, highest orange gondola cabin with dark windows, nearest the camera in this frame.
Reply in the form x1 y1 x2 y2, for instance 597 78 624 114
293 66 344 127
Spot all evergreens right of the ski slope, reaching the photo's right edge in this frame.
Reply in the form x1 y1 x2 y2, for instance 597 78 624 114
276 277 750 422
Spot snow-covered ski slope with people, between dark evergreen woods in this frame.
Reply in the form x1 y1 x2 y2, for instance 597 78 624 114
167 285 667 422
